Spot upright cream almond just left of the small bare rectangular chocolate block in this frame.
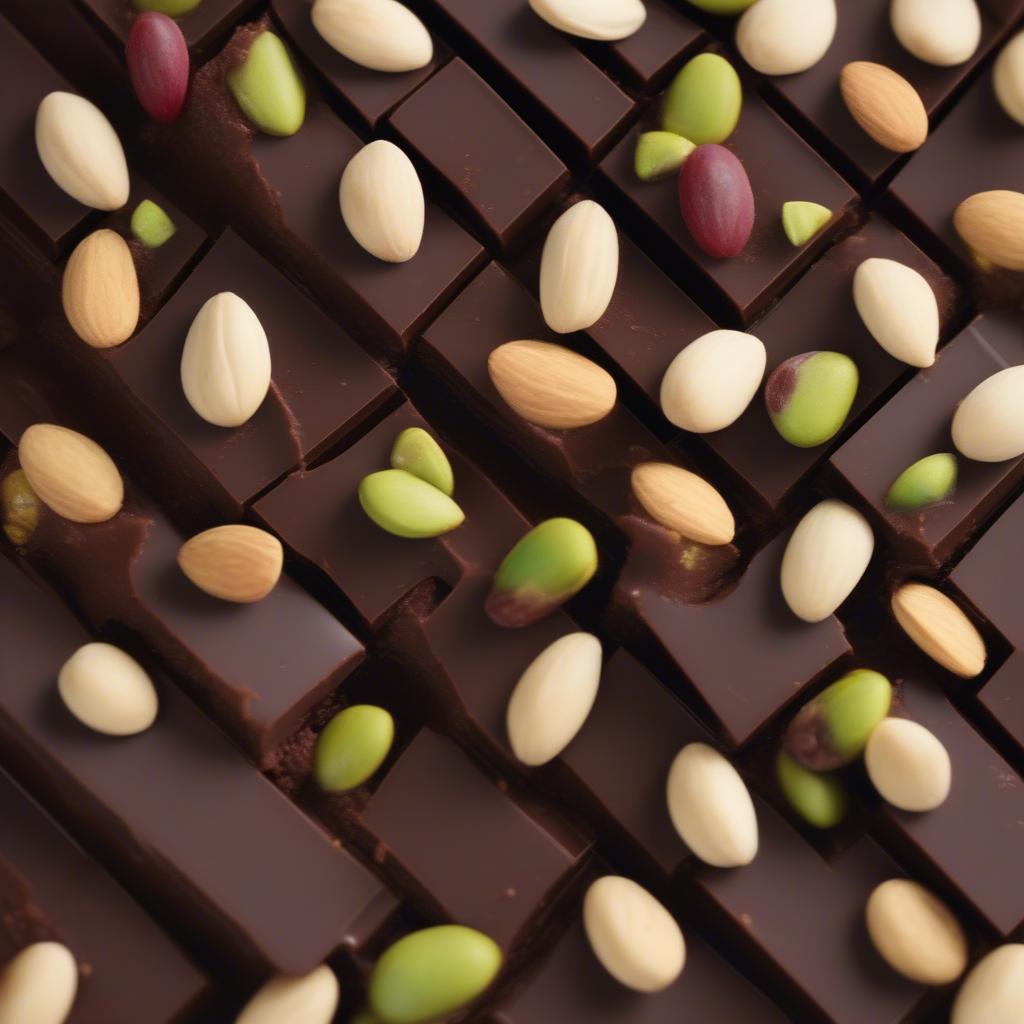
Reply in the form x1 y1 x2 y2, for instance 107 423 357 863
338 138 426 263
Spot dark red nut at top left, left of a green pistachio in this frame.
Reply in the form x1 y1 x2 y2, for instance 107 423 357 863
125 11 188 122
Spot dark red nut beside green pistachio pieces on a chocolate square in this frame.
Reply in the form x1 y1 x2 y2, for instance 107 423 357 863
679 142 754 259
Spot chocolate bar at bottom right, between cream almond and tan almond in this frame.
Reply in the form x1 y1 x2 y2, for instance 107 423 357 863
695 811 926 1024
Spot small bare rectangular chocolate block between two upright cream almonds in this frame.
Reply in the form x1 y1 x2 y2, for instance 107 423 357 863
389 57 568 249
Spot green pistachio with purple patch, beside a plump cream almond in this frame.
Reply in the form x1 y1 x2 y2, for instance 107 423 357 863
765 352 860 447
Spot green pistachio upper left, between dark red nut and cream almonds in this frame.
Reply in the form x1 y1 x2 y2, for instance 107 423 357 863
227 32 306 135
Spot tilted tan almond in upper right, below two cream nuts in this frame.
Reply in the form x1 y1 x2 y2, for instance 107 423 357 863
839 60 928 153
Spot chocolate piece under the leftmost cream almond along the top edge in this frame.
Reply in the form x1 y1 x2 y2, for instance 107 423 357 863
270 0 449 131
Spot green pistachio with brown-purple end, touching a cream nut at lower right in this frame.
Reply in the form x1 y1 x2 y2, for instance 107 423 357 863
782 669 893 771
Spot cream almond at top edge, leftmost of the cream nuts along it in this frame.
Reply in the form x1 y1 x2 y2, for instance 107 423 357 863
311 0 434 72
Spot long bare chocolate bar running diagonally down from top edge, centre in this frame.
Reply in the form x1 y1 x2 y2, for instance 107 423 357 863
428 0 633 164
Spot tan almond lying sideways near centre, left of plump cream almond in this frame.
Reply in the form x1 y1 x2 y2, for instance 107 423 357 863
487 341 616 430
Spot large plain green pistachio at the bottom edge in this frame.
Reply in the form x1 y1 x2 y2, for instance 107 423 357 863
368 925 502 1024
